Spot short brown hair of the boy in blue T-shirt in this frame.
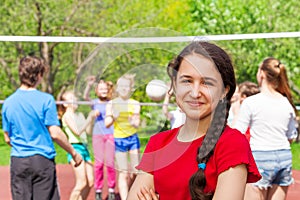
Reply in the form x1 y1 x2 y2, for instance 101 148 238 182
19 56 47 87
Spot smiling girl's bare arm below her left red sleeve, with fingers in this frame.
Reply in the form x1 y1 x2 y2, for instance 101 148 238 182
127 172 158 200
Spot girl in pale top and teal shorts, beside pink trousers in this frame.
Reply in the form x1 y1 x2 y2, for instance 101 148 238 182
62 91 96 199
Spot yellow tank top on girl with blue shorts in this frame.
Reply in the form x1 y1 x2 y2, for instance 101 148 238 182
112 99 137 138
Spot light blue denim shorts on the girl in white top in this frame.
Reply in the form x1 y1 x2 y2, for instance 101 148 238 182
252 149 294 189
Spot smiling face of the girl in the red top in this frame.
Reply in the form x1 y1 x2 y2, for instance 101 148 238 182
174 54 228 120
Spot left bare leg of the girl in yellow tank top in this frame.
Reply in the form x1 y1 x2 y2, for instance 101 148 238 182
116 151 128 200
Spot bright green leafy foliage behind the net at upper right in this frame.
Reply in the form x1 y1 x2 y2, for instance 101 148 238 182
189 0 300 102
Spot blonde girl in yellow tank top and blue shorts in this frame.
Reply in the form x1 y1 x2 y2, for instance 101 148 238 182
105 74 141 200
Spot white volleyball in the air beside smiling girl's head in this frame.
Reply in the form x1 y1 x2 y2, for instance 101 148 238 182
146 79 168 101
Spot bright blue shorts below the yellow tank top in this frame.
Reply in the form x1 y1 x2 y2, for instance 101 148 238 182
115 133 141 152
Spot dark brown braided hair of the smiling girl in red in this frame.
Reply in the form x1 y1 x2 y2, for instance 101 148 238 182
168 41 236 200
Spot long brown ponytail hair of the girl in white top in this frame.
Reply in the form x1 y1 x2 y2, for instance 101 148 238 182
260 57 297 113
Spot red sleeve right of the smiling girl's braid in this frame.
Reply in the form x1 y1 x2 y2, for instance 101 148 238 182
214 127 261 183
